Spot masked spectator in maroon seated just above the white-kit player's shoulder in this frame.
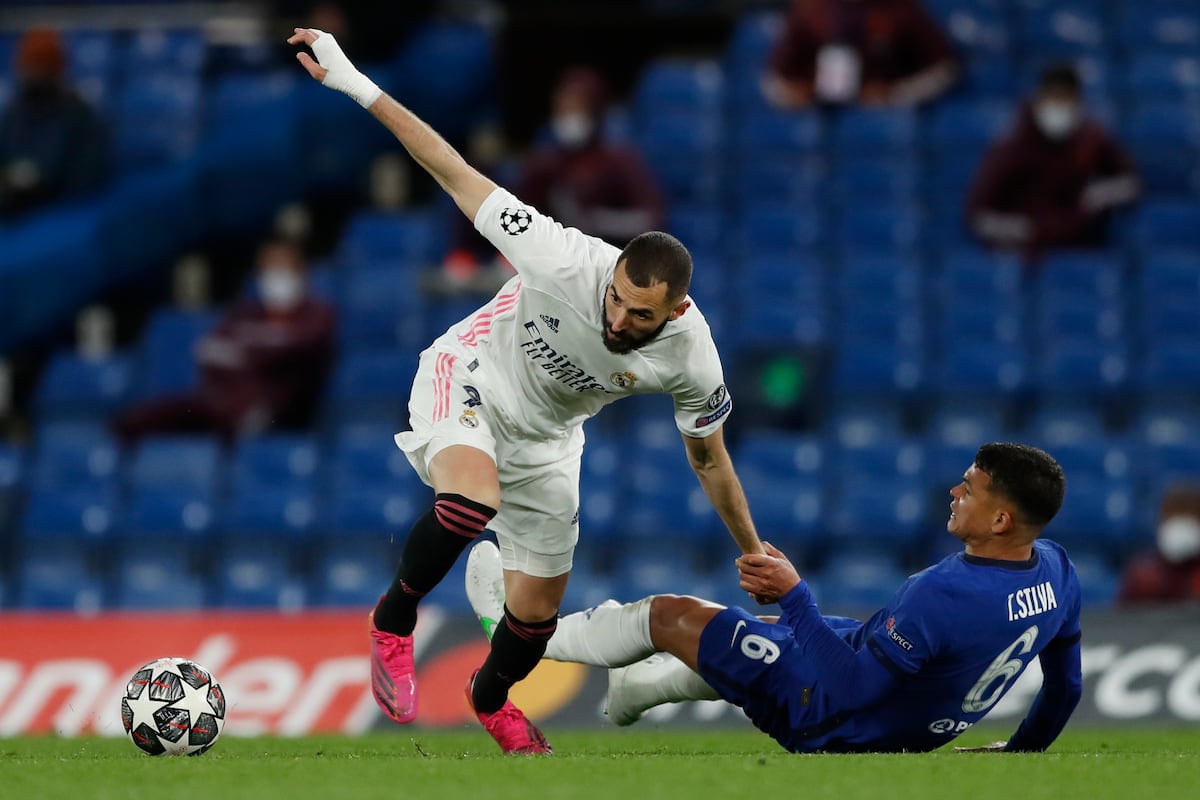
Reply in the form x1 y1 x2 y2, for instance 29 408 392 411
516 67 664 247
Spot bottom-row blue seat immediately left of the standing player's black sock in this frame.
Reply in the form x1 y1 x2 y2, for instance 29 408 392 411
308 540 398 608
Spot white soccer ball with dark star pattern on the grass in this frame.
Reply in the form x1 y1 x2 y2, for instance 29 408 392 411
121 658 224 756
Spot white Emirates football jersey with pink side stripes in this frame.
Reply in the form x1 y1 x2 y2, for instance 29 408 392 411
422 188 733 439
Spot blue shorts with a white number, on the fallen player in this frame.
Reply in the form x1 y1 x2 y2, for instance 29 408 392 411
696 608 833 751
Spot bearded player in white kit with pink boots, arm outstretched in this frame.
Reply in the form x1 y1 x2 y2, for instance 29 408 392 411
288 28 763 753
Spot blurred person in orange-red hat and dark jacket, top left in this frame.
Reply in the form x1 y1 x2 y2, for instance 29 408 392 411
0 29 110 217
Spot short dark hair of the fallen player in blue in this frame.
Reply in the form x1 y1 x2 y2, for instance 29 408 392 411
974 441 1067 530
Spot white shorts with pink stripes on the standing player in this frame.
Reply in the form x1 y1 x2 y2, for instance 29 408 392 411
396 349 583 578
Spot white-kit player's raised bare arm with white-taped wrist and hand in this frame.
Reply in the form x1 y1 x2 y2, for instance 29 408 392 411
288 28 496 222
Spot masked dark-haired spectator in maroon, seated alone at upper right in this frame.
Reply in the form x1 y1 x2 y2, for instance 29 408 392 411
967 65 1139 257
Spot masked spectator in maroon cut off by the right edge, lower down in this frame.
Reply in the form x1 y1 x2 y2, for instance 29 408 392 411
1117 483 1200 604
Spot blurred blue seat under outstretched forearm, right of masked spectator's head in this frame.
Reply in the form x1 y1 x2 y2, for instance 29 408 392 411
338 210 445 272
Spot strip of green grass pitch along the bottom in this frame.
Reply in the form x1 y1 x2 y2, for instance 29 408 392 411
0 728 1200 800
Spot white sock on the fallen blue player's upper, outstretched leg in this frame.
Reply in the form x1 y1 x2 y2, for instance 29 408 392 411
546 597 654 667
